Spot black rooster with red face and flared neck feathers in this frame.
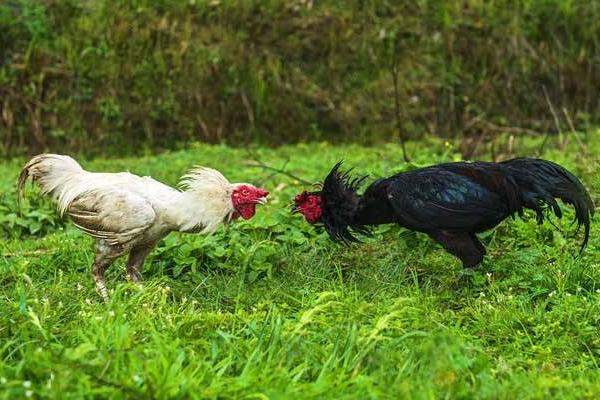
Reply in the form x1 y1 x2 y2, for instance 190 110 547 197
294 158 594 268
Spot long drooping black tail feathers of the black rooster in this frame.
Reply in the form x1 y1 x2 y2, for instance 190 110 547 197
502 158 594 253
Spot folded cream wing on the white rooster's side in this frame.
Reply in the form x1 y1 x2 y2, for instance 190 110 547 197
67 188 156 245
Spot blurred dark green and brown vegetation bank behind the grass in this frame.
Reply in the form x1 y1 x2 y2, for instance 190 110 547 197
0 0 600 155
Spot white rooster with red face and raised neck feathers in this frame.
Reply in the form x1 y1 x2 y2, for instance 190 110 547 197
18 154 269 301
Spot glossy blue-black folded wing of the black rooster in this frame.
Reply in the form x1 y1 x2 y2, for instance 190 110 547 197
387 168 510 232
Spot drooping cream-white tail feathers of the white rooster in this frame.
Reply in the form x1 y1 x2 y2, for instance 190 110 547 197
17 154 86 215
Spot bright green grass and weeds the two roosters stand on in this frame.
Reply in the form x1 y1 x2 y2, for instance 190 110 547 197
0 132 600 399
